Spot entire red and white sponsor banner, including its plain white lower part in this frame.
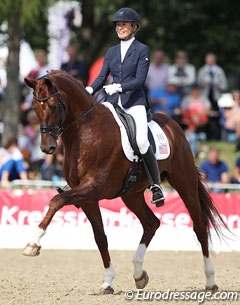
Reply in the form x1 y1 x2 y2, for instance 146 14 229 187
0 190 240 251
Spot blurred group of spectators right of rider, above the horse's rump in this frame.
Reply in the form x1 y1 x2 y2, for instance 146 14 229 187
146 50 236 156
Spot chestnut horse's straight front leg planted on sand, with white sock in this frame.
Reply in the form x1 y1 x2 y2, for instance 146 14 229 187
81 202 115 294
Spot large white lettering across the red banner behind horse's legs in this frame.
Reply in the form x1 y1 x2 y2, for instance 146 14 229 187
0 205 240 230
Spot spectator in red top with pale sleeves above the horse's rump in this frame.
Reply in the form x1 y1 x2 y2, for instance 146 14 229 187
181 83 211 157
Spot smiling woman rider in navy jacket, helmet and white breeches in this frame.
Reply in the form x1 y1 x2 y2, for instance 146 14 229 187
86 7 165 206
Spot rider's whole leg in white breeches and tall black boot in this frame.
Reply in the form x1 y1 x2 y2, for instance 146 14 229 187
124 105 164 206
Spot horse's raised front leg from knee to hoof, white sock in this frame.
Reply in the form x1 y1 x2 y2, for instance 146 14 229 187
22 195 65 256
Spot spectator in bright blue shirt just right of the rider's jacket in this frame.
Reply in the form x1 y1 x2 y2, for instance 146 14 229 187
149 79 181 119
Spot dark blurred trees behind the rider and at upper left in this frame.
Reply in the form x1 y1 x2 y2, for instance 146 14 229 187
0 0 240 147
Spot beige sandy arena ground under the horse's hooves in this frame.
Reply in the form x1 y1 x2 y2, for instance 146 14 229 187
0 249 240 305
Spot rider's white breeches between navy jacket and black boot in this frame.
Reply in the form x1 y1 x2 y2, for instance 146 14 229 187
123 105 150 155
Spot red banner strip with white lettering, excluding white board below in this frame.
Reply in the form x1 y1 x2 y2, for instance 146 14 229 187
0 190 240 229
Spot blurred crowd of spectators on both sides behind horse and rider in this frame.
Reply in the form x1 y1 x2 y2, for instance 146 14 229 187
0 45 240 190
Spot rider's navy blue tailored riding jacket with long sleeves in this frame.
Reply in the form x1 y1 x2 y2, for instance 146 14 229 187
90 39 150 109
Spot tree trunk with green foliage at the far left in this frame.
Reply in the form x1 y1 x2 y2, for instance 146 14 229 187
0 0 47 145
